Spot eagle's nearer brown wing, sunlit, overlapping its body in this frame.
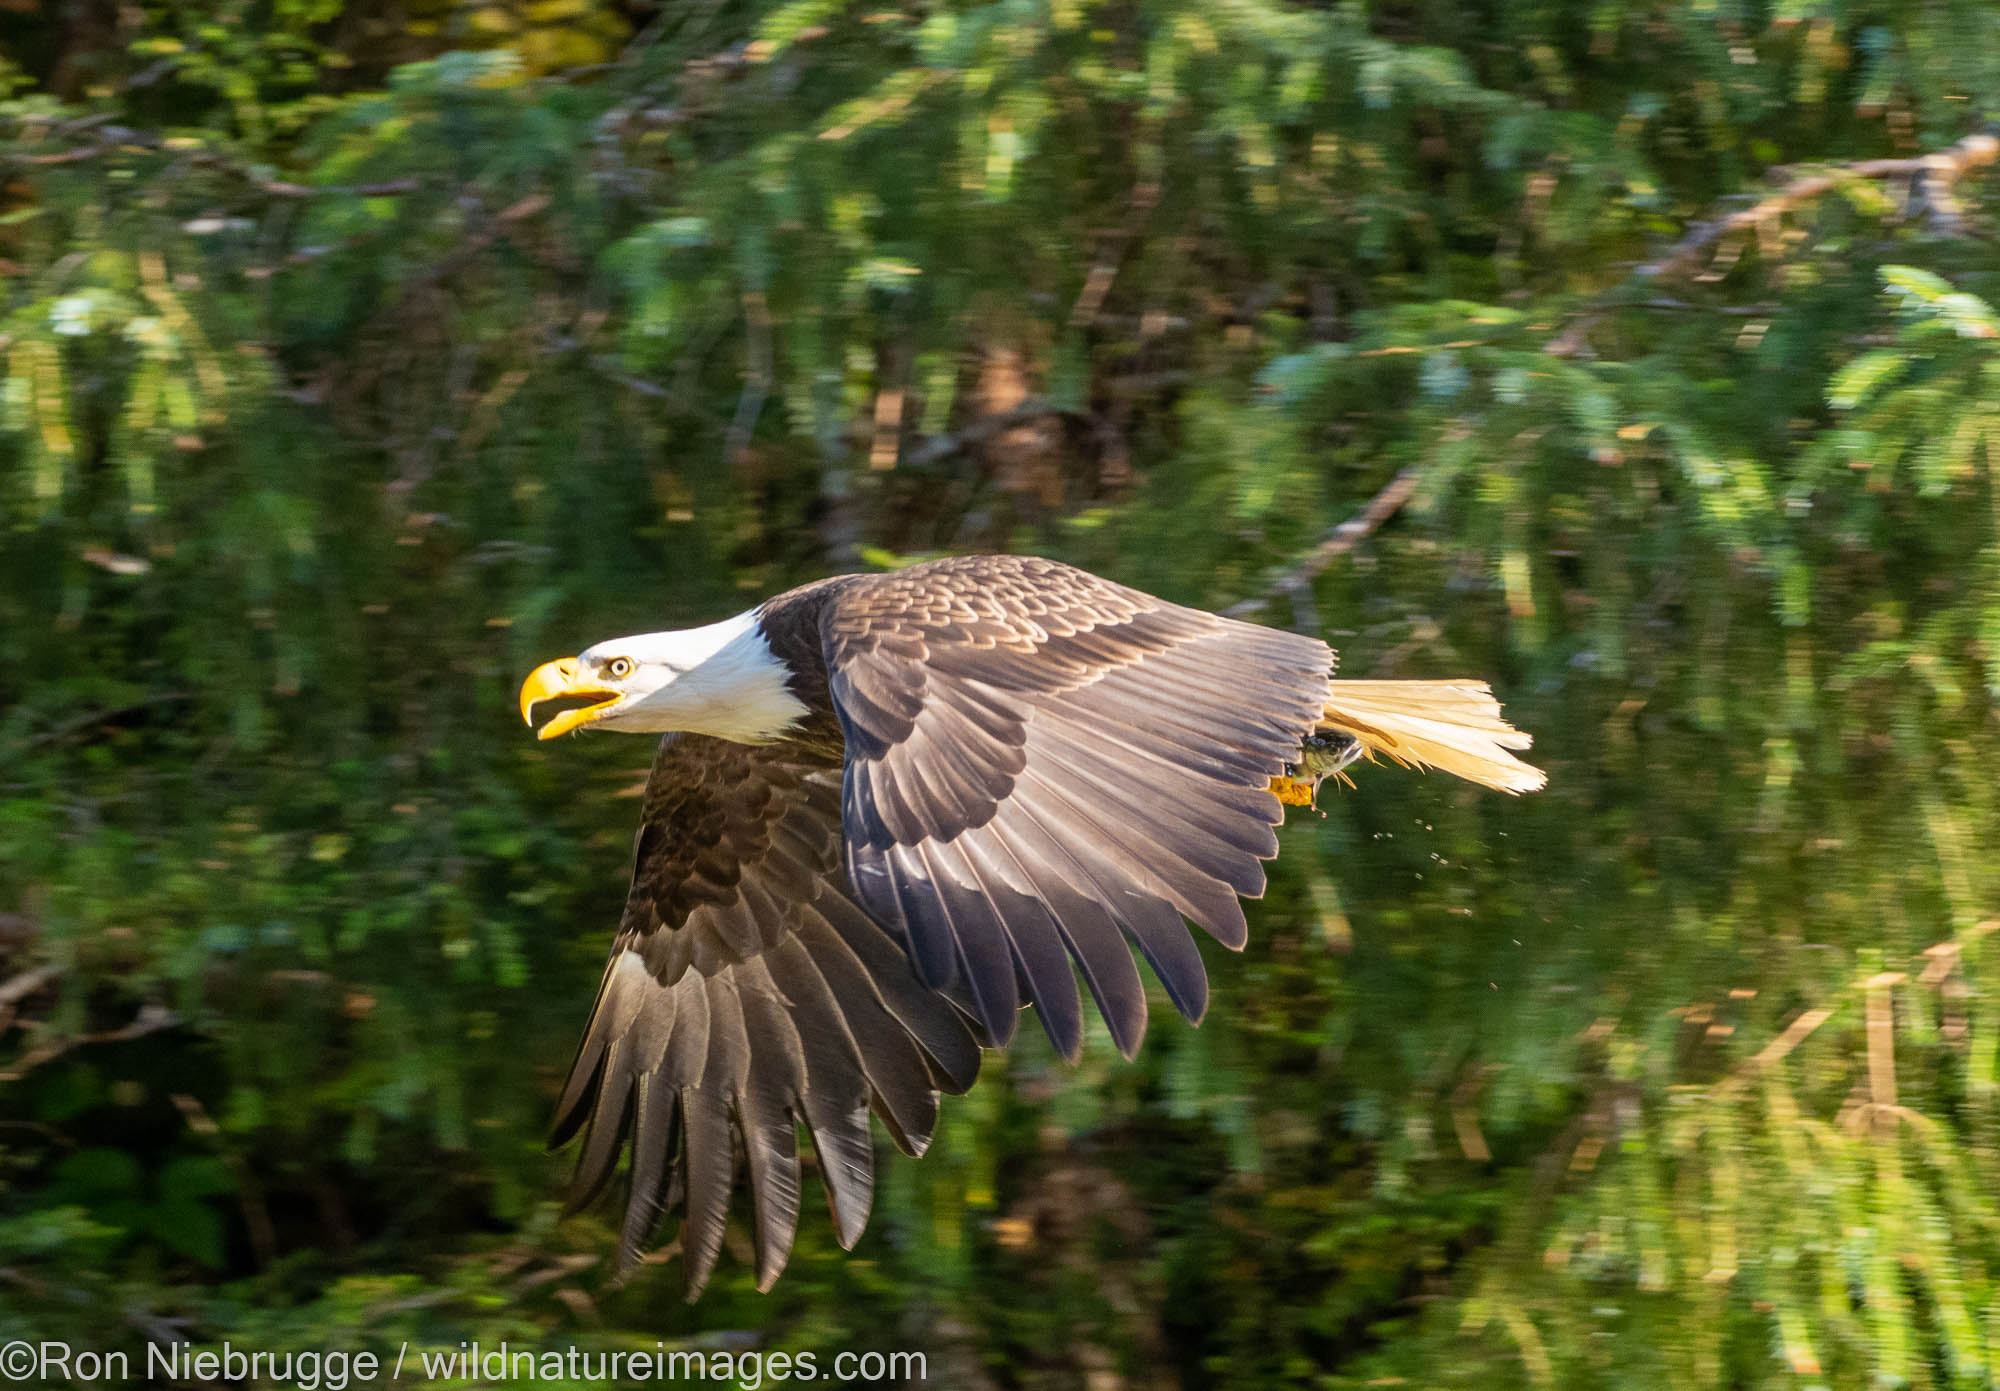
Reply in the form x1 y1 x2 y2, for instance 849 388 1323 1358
822 556 1334 1057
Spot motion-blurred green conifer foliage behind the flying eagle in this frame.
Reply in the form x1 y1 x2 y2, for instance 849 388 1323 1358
0 0 2000 1391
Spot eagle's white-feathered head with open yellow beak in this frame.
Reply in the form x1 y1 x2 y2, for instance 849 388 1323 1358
520 610 806 743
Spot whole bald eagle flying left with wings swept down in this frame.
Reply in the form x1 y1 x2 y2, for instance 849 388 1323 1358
520 556 1544 1299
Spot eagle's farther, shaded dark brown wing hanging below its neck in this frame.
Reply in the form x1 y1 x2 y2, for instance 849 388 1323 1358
556 735 980 1299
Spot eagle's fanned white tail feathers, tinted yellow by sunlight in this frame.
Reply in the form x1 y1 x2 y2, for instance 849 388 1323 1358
1320 682 1548 791
